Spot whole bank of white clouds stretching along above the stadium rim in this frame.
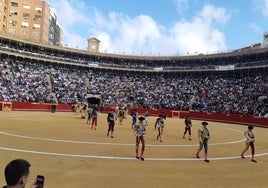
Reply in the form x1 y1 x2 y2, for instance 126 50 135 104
47 0 229 55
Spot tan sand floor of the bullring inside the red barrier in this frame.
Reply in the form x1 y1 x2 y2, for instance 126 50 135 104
0 111 268 188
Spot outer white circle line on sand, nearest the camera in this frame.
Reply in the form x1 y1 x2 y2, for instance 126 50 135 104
0 147 268 161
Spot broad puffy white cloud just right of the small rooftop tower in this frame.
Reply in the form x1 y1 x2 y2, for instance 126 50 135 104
95 13 162 54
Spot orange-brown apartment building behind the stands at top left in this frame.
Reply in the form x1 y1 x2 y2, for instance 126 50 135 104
0 0 62 46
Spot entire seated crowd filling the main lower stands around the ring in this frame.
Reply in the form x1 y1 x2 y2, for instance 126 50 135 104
0 58 268 116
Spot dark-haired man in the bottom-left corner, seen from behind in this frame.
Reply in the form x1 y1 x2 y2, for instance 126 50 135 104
2 159 38 188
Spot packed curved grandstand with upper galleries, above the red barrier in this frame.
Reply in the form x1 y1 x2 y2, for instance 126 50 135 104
0 37 268 117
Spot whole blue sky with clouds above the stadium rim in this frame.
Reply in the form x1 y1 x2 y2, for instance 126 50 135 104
47 0 268 56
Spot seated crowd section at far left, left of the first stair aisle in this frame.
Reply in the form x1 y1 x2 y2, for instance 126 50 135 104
0 60 50 102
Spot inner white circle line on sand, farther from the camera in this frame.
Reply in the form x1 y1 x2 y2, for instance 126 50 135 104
0 131 245 147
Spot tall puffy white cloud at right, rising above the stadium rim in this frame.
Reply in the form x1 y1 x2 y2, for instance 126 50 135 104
172 5 229 53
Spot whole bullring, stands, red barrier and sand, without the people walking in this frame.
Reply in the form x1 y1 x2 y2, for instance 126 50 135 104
0 36 268 188
